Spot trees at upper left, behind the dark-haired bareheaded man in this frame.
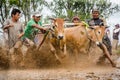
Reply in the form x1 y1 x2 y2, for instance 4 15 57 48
0 0 48 24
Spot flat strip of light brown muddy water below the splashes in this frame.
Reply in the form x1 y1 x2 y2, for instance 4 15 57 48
0 67 120 80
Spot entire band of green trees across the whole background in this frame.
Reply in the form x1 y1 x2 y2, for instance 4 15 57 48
0 0 120 24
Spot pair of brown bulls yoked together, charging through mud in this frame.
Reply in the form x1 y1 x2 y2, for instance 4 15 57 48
38 18 115 67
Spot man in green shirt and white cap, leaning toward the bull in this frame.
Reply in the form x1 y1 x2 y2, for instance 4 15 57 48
22 12 46 46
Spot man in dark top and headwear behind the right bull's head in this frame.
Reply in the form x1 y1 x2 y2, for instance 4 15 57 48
88 9 112 62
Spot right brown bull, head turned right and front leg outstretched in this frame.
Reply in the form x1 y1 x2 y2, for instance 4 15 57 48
65 26 115 66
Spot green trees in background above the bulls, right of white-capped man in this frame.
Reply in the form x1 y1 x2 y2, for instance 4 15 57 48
49 0 120 20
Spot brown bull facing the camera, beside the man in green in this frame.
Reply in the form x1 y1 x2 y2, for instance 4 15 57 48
44 18 66 63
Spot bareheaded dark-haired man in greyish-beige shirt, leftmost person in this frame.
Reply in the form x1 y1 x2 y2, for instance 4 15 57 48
3 8 23 53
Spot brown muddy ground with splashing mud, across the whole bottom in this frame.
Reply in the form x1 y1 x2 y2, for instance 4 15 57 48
0 42 120 80
